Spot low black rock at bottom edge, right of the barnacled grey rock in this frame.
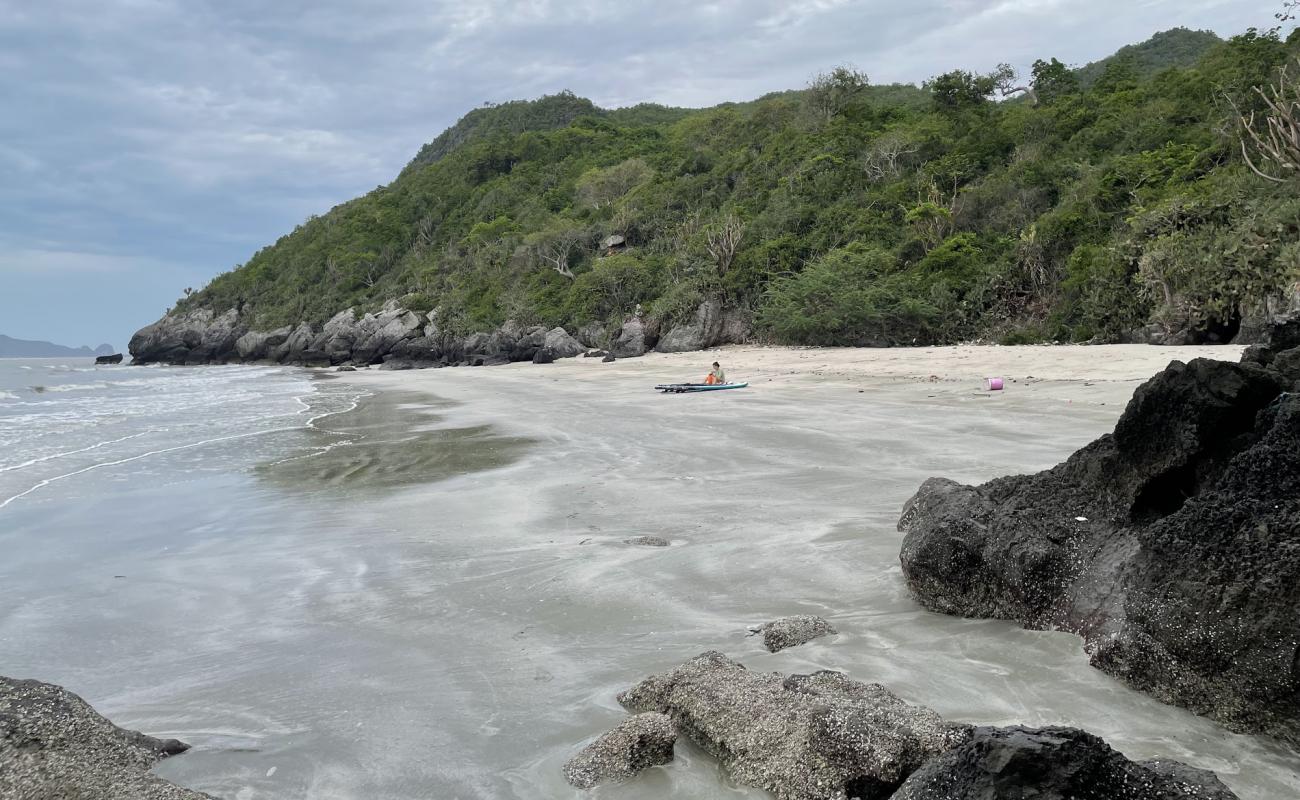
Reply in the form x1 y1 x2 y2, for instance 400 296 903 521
893 727 1236 800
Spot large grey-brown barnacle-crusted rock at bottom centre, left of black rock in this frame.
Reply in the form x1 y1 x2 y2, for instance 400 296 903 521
619 652 970 800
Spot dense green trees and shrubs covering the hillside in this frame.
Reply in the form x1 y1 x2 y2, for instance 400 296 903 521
179 31 1300 345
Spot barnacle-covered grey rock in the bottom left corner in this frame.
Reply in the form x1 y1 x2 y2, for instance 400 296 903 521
0 676 208 800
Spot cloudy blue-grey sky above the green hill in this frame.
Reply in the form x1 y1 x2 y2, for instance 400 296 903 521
0 0 1281 350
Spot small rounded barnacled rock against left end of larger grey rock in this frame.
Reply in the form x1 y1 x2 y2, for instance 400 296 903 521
563 713 677 788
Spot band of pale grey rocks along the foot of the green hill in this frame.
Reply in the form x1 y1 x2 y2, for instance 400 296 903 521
130 303 749 368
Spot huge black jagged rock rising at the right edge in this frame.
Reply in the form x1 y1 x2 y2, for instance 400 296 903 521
898 328 1300 747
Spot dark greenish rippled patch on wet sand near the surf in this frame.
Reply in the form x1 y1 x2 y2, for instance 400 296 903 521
256 392 533 490
